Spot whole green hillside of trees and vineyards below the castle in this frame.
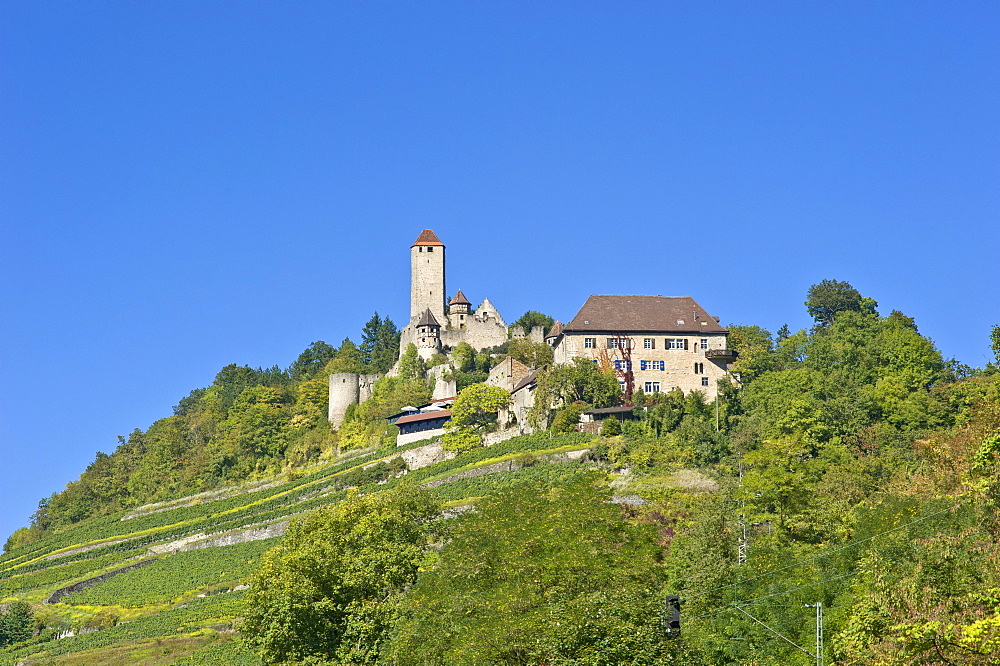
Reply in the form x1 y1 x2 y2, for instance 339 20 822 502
0 281 1000 666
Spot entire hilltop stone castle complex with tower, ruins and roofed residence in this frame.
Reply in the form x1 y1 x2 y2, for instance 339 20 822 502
329 229 736 428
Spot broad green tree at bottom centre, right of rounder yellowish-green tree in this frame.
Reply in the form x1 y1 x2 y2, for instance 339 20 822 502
390 472 695 666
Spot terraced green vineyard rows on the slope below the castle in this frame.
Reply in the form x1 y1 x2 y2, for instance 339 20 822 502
0 433 591 665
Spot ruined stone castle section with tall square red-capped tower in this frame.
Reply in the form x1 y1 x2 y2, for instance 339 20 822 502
399 229 507 359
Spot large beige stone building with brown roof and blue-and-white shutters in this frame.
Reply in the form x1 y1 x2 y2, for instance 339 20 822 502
547 296 736 400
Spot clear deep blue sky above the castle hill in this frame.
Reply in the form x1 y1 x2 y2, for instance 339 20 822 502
0 0 1000 539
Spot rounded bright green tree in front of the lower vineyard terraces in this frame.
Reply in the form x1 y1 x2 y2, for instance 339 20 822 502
242 484 440 664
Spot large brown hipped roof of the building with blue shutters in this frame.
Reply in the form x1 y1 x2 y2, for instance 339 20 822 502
563 295 726 333
